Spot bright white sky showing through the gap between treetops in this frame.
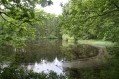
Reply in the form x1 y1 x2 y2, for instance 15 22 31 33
37 0 68 15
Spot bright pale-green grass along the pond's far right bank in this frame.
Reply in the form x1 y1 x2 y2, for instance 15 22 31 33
62 34 116 47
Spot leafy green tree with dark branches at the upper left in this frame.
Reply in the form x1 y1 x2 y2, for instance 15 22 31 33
0 0 52 46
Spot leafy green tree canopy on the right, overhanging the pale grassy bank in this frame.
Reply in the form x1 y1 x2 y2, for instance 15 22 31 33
62 0 119 41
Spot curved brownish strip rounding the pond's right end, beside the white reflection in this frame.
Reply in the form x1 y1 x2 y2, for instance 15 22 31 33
63 48 109 69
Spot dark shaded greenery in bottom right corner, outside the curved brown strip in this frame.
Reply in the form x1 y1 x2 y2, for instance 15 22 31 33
64 47 119 79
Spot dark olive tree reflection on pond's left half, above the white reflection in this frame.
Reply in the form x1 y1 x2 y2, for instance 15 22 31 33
0 39 62 63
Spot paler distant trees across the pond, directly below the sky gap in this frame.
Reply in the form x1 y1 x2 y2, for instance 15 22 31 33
35 11 61 39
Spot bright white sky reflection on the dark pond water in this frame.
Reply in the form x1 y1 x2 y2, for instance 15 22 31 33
27 58 63 74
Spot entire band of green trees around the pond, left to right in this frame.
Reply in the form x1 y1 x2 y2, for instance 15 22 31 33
0 0 119 46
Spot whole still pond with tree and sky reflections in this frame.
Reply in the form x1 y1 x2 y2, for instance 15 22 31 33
0 39 117 79
